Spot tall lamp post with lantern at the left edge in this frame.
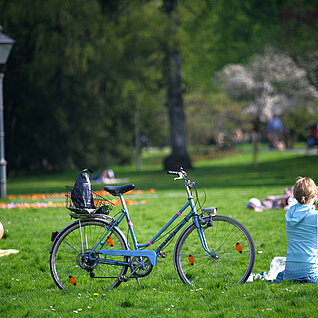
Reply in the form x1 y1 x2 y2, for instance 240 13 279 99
0 25 14 198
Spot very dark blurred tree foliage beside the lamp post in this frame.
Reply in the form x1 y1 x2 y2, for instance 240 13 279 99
0 0 133 171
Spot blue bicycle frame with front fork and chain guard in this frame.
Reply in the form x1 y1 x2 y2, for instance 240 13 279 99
84 181 215 266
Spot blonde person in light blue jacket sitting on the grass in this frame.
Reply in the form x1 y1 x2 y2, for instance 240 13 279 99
276 177 318 283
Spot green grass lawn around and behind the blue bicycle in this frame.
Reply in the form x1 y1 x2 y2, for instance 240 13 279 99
0 151 318 317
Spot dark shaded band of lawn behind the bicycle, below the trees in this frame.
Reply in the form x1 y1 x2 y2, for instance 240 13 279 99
8 153 318 194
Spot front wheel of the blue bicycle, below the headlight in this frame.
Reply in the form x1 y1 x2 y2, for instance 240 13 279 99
174 215 255 288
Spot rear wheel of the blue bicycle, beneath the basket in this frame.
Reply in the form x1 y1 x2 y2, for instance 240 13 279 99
50 219 128 292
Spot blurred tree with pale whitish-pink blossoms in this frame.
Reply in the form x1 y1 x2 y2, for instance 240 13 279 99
219 48 318 165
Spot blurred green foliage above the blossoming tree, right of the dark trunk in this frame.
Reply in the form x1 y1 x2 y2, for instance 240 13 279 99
182 0 318 91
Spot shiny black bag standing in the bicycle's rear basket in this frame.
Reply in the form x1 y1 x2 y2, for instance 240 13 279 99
71 169 96 209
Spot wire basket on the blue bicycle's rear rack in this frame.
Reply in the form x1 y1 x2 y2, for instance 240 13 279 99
65 186 114 214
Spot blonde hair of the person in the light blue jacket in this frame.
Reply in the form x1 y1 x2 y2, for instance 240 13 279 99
293 177 317 204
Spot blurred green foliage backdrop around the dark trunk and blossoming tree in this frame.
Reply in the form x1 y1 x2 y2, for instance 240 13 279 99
0 0 318 174
